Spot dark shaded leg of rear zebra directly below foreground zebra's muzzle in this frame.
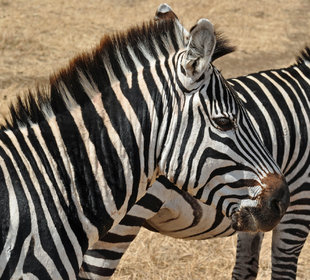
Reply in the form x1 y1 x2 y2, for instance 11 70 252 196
232 232 264 280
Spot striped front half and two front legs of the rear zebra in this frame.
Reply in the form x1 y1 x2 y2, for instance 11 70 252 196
230 47 310 280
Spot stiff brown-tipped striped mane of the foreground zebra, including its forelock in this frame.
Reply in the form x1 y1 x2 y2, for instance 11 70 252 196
1 19 234 129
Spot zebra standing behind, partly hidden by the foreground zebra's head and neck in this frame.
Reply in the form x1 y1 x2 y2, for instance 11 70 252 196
80 44 310 280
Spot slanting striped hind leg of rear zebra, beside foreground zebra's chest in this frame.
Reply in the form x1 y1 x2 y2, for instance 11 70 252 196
79 181 167 280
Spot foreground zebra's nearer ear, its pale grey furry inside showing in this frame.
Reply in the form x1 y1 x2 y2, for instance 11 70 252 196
183 19 216 81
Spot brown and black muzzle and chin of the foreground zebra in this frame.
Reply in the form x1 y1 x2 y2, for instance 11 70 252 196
231 174 290 232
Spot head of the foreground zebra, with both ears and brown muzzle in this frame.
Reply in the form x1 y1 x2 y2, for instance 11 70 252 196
156 5 289 231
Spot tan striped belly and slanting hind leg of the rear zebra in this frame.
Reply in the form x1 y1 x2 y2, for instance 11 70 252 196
79 176 235 280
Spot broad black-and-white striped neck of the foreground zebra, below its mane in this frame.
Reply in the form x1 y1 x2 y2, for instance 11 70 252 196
0 41 183 244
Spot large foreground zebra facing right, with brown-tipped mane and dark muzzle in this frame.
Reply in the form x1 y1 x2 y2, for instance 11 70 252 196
0 4 289 279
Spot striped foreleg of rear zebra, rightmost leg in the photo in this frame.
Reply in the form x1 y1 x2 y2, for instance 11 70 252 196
271 219 309 280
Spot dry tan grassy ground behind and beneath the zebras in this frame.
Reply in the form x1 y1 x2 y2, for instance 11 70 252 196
0 0 310 280
